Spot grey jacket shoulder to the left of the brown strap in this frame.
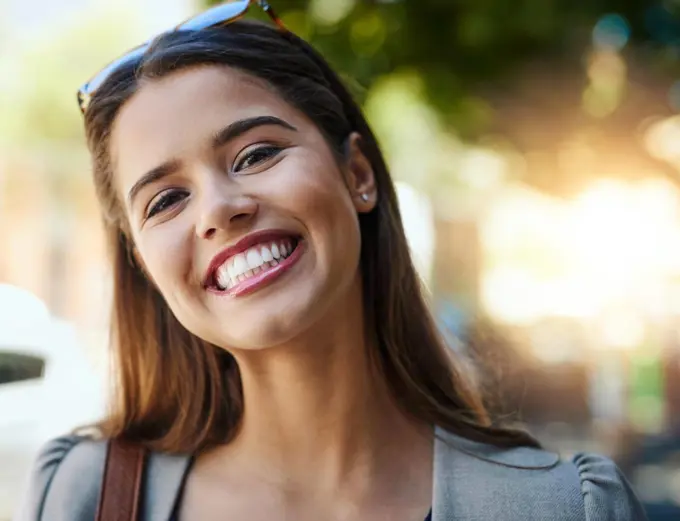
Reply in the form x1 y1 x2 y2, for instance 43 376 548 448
15 435 106 521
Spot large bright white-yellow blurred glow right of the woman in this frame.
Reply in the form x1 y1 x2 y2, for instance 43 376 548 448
482 178 680 324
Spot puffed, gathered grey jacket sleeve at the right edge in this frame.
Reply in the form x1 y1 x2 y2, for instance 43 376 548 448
573 454 647 521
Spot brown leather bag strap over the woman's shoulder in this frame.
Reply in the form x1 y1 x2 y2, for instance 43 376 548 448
97 440 146 521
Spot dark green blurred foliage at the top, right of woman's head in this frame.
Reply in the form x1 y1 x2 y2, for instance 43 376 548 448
207 0 650 135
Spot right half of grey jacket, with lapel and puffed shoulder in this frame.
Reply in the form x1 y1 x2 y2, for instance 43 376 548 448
435 430 647 521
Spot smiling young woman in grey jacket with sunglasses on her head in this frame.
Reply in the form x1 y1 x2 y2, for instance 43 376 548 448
14 1 644 521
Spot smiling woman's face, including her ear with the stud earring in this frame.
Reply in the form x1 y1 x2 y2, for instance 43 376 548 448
111 66 375 349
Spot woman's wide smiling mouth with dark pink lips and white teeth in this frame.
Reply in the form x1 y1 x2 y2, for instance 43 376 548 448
206 234 303 296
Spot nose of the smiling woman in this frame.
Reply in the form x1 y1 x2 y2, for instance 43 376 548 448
196 179 258 239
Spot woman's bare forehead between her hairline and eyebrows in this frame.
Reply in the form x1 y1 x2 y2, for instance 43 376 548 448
111 66 304 188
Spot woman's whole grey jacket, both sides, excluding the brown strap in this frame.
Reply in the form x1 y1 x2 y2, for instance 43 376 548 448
15 429 647 521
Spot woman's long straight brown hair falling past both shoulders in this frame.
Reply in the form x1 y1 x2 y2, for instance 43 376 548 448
85 21 537 452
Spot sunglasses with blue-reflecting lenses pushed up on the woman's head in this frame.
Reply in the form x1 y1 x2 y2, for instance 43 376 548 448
78 0 286 114
